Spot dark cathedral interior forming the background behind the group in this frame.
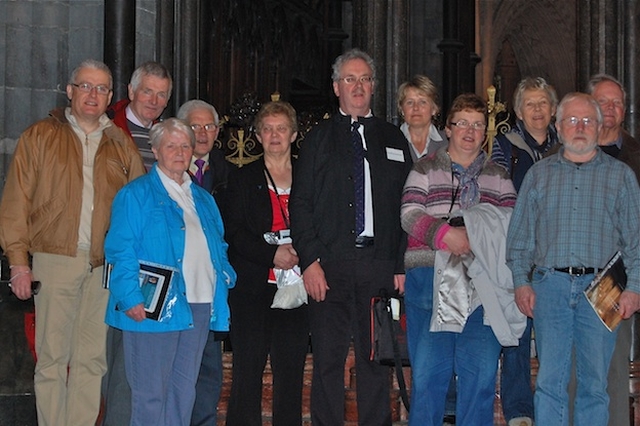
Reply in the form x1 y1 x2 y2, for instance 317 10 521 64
0 0 640 425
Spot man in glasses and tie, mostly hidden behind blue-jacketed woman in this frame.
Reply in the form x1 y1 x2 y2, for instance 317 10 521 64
177 99 230 426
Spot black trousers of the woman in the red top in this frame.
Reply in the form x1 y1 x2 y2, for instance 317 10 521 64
226 283 309 426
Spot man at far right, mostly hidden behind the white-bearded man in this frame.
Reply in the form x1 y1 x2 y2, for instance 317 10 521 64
588 74 640 426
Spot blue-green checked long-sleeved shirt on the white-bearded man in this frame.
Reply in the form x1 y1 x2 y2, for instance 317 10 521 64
507 148 640 293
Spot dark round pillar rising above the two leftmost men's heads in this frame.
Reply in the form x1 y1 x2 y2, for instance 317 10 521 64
104 0 136 101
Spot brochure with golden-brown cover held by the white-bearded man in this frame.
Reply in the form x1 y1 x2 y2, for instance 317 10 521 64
584 251 627 331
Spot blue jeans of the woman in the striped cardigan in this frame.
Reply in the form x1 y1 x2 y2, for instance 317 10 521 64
405 267 502 426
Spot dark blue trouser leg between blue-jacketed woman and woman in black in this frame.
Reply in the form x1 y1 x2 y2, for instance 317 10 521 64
191 331 222 426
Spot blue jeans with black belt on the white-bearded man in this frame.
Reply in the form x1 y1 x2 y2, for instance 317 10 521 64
532 268 616 426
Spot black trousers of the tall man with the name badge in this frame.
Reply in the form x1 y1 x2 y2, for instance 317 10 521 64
309 247 395 426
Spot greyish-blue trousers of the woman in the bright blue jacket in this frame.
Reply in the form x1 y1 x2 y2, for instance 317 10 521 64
123 303 211 426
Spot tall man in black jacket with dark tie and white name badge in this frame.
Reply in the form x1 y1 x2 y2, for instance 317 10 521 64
289 49 412 426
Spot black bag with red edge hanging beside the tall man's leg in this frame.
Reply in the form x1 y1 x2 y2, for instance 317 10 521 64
369 290 410 411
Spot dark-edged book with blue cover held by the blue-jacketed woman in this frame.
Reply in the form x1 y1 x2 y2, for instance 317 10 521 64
102 261 177 321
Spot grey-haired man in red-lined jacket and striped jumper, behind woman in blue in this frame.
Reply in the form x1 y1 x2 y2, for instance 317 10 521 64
107 61 173 171
